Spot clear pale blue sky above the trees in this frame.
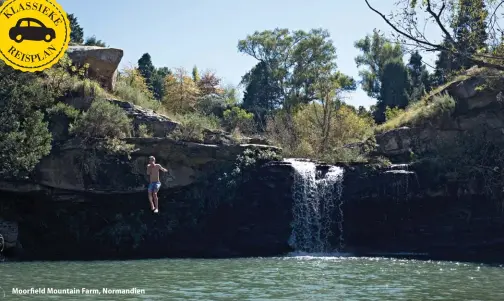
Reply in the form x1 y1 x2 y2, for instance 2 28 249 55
58 0 440 107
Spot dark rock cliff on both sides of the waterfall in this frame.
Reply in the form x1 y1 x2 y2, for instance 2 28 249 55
0 49 504 262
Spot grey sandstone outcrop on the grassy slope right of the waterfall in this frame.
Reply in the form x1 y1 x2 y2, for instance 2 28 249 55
376 68 504 158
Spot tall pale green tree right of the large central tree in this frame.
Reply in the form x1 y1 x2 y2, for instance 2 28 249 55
354 29 404 98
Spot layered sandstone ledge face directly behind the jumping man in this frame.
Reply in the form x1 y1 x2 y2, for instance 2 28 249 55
0 138 281 194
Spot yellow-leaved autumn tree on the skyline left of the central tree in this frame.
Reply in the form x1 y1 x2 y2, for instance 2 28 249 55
163 68 200 113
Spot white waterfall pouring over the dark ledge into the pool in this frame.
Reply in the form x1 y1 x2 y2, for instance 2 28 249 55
286 159 343 253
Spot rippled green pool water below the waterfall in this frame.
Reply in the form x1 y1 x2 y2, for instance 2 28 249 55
0 254 504 301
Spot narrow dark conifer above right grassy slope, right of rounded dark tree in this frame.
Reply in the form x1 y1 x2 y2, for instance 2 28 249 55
407 51 431 101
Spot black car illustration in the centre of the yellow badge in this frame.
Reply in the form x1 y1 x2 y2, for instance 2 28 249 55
9 18 56 43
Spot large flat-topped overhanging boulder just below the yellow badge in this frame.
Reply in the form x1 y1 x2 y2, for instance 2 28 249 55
67 46 123 91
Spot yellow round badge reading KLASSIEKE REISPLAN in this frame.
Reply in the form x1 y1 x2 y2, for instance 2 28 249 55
0 0 70 72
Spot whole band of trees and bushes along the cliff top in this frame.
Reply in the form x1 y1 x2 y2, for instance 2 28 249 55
0 0 504 175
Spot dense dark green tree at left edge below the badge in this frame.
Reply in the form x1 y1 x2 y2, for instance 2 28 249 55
0 61 53 178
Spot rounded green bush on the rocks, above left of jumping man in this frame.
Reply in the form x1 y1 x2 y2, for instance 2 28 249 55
71 100 132 140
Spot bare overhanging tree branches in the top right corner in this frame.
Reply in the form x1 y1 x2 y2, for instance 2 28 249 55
364 0 504 70
